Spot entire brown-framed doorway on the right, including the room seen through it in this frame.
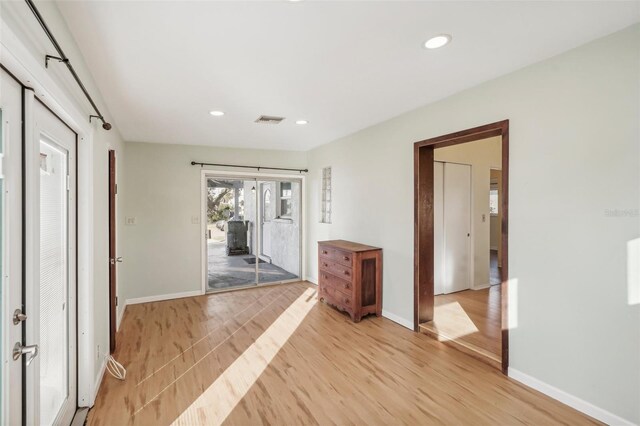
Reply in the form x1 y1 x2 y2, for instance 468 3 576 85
414 120 509 373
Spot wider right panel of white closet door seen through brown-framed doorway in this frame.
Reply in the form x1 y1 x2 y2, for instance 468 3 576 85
443 163 471 293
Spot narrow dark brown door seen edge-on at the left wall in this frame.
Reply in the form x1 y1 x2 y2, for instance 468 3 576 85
109 150 118 353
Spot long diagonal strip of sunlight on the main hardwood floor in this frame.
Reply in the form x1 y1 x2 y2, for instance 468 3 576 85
173 288 316 425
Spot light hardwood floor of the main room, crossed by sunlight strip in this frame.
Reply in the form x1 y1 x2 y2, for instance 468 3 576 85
88 283 593 425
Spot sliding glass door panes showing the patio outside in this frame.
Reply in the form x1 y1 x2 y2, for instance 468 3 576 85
203 172 302 292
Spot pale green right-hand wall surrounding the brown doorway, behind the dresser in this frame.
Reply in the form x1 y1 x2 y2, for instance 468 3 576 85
307 25 640 423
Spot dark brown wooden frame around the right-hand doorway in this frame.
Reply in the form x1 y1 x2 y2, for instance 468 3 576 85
413 120 509 374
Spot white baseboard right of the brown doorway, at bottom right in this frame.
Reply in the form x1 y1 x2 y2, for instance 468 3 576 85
509 368 633 426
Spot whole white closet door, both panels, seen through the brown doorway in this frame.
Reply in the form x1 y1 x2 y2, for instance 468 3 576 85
434 162 472 294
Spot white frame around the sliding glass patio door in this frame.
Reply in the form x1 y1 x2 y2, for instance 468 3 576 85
200 168 307 294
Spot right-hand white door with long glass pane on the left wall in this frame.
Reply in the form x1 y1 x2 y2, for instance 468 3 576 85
23 95 76 425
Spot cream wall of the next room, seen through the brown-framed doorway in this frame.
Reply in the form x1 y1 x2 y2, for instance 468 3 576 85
434 136 502 288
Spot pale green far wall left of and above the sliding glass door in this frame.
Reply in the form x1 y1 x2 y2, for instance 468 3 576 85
121 142 307 300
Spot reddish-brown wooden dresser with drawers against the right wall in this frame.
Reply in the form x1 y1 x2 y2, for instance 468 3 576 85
318 240 382 322
